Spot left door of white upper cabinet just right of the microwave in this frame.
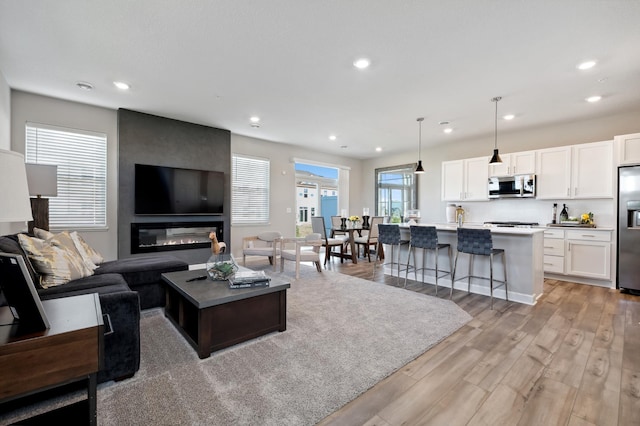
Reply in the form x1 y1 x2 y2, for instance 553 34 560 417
536 146 571 199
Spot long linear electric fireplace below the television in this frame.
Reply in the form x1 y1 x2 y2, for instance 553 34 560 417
131 221 224 254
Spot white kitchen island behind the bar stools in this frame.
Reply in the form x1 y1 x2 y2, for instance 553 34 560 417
385 223 546 305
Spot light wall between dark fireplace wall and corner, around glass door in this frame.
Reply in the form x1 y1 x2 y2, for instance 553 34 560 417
231 133 363 260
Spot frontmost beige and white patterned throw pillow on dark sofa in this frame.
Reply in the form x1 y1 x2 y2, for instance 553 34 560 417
18 234 93 288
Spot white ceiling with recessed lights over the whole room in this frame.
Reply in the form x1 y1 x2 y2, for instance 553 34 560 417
0 0 640 158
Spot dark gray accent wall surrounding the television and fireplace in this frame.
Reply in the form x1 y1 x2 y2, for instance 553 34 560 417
118 109 231 264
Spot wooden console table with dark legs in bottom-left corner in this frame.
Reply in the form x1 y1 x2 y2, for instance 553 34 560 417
0 293 104 425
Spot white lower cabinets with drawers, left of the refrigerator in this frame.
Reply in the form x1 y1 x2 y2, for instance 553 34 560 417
544 229 611 280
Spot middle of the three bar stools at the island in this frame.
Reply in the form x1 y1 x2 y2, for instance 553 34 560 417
404 226 453 296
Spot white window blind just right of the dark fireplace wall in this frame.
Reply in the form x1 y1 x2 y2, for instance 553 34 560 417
231 154 270 224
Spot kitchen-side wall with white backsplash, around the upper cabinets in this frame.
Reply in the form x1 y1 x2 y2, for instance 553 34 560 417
362 110 640 227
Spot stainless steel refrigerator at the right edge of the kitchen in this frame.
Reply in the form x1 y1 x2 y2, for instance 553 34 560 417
617 166 640 293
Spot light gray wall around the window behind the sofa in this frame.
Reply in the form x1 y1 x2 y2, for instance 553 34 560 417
11 90 118 260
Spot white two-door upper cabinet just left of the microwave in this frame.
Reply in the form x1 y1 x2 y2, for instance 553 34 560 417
441 157 489 201
